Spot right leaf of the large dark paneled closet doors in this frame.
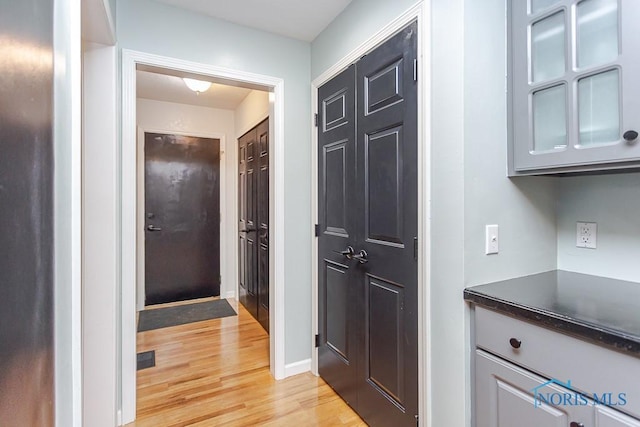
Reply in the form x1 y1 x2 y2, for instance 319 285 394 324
354 20 418 426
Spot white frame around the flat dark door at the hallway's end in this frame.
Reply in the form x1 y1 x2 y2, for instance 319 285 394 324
136 126 229 311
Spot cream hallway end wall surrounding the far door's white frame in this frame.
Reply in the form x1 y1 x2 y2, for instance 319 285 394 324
137 99 238 300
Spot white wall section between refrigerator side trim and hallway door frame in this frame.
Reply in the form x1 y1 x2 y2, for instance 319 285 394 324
82 41 118 427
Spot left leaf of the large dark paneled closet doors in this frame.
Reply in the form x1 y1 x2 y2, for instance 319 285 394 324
318 65 361 408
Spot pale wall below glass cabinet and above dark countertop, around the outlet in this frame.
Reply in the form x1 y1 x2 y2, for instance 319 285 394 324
557 173 640 282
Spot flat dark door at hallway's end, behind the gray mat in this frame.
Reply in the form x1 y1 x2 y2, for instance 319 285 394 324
145 133 220 305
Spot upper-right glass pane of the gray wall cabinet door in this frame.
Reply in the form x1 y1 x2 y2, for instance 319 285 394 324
576 0 618 68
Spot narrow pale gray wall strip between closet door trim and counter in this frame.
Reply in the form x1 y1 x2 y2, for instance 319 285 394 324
426 0 468 427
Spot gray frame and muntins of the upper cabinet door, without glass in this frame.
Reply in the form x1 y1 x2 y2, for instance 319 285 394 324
507 0 640 176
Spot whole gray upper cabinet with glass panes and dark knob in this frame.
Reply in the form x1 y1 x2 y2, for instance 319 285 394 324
509 0 640 175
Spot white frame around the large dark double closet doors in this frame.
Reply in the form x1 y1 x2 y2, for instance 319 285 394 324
311 0 431 426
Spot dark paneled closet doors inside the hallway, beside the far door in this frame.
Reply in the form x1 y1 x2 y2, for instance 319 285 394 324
238 119 269 331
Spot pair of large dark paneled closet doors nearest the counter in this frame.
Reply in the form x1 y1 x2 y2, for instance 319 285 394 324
318 24 418 426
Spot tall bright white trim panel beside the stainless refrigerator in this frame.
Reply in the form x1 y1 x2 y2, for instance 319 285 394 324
53 0 82 427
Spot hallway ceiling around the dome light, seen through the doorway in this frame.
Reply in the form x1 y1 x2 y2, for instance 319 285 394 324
136 70 251 110
